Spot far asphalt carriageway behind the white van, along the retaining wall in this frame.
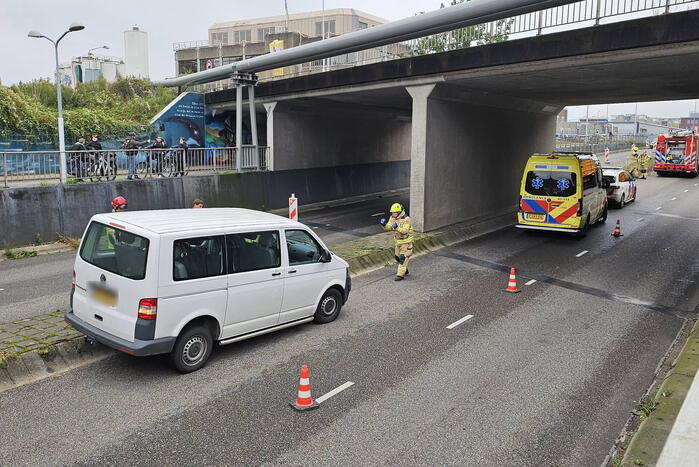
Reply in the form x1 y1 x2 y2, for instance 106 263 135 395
0 190 409 323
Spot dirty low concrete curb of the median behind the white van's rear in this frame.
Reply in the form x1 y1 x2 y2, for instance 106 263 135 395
0 337 116 392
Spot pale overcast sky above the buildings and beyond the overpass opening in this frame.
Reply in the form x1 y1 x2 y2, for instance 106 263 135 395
0 0 695 119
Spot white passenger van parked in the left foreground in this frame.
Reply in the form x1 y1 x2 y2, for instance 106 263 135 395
65 209 352 373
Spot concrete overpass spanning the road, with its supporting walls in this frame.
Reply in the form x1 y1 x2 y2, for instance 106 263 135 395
206 11 699 231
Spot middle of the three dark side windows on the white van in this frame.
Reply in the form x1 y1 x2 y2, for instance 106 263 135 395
226 230 282 274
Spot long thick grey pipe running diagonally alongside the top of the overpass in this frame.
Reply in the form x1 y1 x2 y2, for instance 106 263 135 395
153 0 579 86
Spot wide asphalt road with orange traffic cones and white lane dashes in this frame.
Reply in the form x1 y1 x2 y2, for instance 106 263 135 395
0 168 699 466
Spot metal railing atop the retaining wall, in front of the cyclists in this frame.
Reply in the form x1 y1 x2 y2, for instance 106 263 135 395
0 146 270 188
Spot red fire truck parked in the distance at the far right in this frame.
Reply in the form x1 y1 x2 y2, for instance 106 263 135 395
653 130 699 177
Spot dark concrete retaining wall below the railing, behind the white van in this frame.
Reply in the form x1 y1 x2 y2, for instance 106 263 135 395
0 161 410 247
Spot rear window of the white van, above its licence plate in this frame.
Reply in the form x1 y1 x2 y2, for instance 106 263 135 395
80 222 150 280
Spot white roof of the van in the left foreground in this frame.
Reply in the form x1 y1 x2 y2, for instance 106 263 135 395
95 208 298 234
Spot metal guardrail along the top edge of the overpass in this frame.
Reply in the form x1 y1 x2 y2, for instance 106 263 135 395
186 0 699 92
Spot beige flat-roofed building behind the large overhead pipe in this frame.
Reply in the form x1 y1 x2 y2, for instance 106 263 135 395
173 8 387 76
